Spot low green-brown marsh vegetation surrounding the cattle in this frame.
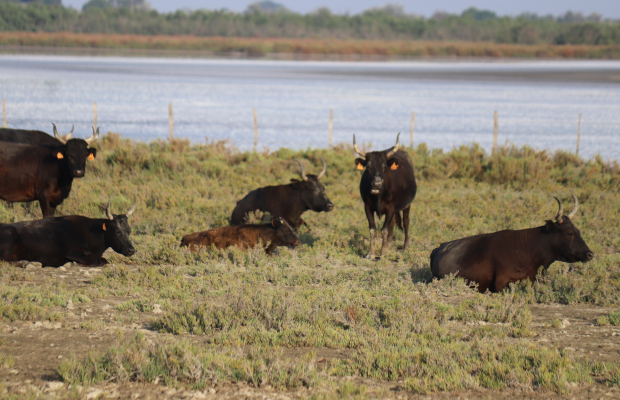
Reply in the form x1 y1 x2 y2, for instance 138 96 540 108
0 134 620 398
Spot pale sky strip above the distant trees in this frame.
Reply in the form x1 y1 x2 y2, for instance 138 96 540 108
63 0 620 19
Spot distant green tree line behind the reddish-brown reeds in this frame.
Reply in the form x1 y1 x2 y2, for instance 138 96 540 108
0 0 620 45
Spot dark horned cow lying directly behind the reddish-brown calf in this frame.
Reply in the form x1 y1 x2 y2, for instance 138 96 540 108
230 158 334 228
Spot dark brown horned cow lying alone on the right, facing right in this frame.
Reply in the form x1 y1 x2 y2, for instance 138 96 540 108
431 195 594 293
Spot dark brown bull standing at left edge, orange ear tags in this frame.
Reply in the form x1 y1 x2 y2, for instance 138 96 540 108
0 125 99 218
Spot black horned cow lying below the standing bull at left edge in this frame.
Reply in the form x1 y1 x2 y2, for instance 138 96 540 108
0 201 137 267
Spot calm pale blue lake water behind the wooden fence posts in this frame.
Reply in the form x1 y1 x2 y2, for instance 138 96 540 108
0 55 620 159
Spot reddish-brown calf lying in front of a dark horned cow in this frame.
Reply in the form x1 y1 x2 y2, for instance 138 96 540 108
181 218 299 255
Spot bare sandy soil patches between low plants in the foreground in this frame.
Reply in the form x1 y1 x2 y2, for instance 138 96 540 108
0 265 620 399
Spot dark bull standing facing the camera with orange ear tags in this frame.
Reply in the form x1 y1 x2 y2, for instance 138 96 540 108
353 133 417 258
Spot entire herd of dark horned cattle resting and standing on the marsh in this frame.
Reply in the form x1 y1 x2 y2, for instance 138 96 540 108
0 128 594 292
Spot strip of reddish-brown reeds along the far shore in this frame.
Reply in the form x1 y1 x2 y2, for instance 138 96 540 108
0 32 620 59
